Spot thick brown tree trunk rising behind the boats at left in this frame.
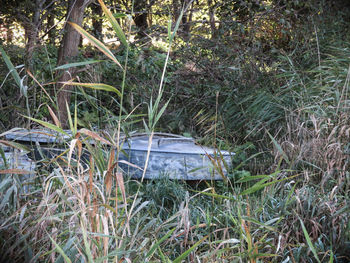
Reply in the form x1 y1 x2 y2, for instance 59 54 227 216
57 0 90 128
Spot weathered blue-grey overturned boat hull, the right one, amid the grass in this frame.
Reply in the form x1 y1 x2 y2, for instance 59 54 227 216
120 133 233 180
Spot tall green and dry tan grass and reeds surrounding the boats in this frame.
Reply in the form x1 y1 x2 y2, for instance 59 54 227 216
0 1 350 262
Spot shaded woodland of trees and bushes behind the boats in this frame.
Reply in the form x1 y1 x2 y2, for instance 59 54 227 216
0 0 350 169
